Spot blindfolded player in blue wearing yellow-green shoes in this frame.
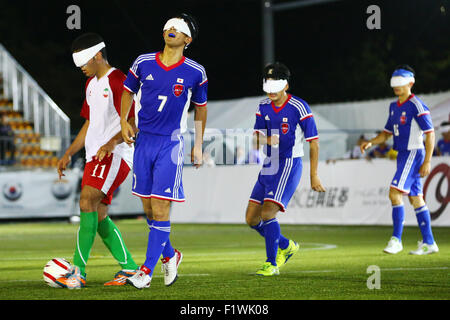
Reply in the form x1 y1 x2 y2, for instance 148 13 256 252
246 62 325 276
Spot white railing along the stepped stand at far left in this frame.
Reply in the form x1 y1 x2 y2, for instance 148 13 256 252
0 44 70 151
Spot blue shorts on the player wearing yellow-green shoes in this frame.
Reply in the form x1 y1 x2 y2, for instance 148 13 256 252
249 157 302 212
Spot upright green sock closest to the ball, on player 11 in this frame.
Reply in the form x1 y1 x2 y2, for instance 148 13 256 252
73 212 98 275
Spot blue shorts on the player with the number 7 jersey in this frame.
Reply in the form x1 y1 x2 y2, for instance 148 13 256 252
132 132 184 202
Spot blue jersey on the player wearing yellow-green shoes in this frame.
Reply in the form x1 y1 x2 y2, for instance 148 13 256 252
254 94 319 158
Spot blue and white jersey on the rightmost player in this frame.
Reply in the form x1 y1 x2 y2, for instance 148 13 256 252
384 95 434 151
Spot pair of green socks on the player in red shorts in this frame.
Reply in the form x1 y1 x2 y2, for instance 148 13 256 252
73 212 139 276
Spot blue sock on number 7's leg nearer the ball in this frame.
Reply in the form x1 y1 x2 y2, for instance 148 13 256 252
144 220 170 276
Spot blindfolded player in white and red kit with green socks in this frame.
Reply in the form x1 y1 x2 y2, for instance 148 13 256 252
56 33 139 289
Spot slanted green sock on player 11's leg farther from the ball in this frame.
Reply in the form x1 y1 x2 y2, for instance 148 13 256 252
97 217 139 270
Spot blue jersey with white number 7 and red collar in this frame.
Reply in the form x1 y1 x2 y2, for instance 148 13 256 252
124 52 208 136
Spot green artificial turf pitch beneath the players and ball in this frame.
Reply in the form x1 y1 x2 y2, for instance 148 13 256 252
0 219 450 300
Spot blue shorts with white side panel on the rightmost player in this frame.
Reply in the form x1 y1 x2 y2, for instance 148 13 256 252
391 149 425 196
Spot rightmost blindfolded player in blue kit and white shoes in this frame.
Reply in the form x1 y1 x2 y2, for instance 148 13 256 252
361 65 439 255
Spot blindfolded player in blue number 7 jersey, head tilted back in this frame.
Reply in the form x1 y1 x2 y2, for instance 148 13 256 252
121 14 208 289
